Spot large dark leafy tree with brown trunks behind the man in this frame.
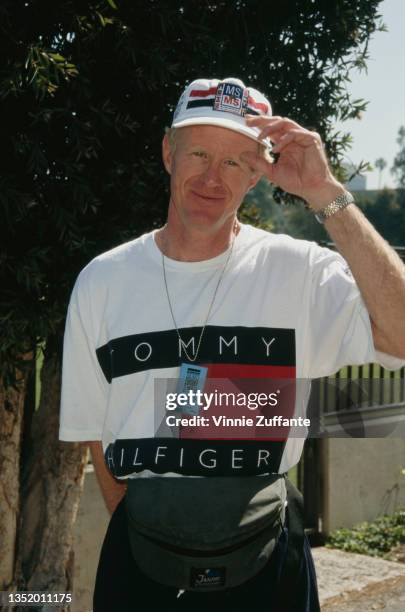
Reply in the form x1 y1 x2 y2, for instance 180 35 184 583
0 0 382 604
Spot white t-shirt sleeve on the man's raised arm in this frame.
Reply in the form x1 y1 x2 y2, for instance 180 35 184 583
306 247 405 378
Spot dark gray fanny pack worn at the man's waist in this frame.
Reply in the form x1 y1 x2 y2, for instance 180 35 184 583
125 475 287 591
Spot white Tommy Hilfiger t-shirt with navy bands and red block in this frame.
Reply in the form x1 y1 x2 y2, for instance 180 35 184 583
59 225 402 478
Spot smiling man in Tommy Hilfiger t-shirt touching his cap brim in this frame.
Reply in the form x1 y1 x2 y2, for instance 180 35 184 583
60 78 405 612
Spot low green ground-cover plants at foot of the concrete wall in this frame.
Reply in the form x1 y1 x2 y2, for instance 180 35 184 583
326 508 405 558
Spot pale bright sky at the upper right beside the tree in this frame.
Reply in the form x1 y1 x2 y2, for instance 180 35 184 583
337 0 405 189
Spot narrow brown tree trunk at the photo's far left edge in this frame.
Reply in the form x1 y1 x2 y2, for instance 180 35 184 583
0 373 27 591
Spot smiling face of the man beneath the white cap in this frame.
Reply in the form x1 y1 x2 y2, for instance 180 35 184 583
163 125 259 233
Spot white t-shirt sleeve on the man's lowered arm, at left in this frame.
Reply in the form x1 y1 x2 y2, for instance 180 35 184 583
59 276 108 442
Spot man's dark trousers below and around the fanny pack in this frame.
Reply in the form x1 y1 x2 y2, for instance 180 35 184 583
93 500 320 612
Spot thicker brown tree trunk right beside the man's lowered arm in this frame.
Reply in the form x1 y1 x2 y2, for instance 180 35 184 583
17 340 88 612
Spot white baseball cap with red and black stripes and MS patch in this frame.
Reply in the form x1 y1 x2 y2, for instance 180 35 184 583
172 77 272 148
